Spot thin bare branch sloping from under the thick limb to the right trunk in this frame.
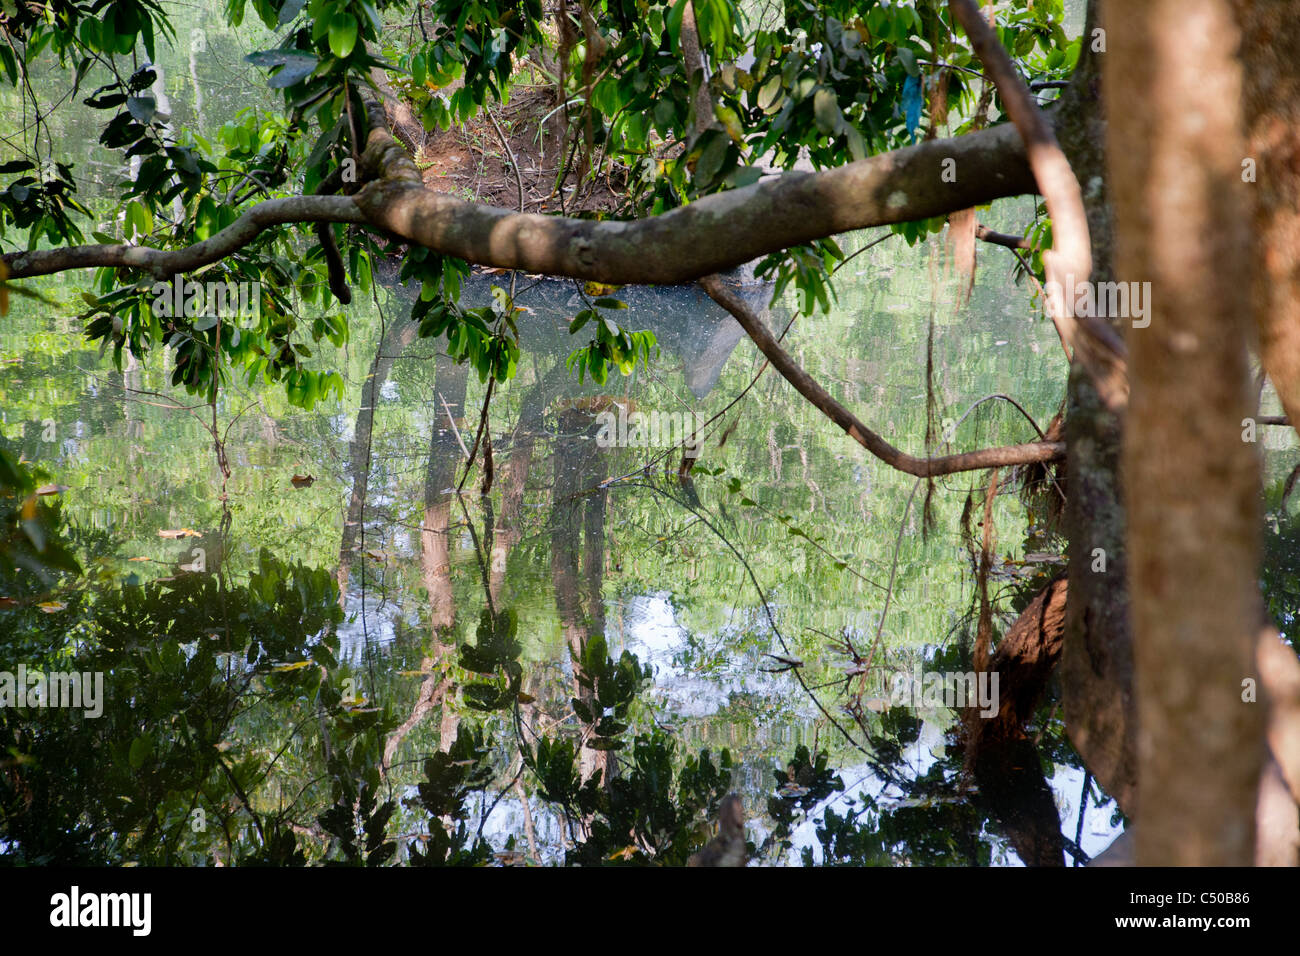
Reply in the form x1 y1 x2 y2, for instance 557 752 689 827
699 276 1065 477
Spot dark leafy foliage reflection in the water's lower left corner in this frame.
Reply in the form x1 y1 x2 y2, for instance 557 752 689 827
0 538 351 864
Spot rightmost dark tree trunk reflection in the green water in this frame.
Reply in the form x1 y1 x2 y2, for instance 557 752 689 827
551 407 616 783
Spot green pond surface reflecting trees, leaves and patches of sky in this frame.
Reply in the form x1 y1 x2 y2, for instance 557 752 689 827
12 218 1294 865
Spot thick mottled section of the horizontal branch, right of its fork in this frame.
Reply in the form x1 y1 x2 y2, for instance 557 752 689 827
356 125 1036 285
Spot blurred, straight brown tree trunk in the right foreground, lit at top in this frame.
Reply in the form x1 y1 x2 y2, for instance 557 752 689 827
1104 0 1258 866
